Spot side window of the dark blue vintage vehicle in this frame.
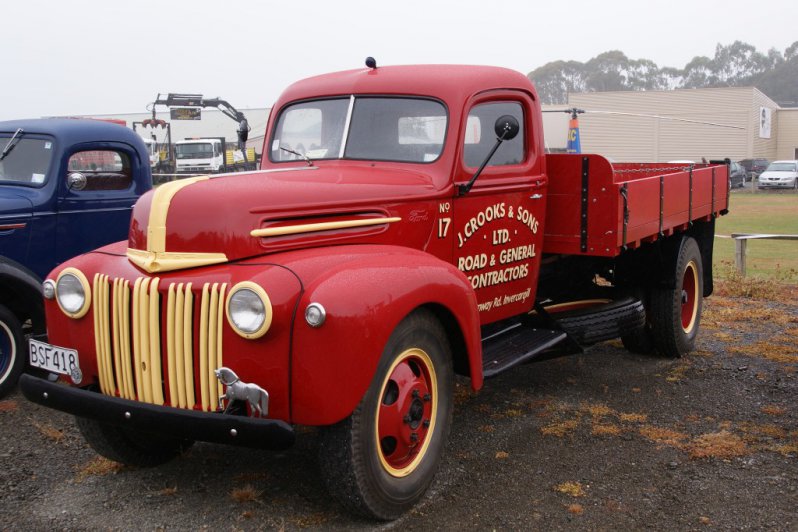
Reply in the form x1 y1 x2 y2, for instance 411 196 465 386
67 150 133 191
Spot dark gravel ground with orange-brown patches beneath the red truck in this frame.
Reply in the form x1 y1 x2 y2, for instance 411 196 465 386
0 288 798 530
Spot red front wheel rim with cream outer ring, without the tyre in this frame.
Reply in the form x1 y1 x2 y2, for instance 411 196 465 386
375 348 438 477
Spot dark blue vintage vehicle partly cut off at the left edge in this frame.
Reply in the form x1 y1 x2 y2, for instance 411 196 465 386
0 118 152 397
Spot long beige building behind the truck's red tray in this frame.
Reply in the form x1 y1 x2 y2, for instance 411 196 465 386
544 87 798 162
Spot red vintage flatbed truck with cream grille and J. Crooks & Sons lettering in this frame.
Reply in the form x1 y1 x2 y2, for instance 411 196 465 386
21 63 729 519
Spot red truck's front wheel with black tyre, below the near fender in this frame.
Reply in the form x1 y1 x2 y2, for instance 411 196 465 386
319 311 454 520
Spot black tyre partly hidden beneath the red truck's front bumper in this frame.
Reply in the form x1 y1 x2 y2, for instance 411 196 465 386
75 416 194 467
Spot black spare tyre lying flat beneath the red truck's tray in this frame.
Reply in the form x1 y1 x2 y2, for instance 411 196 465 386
546 297 646 346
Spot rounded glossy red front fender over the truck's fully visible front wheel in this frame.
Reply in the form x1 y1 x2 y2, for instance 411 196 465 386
290 246 482 425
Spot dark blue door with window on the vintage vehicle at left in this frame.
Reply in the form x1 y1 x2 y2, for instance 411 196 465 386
56 143 149 263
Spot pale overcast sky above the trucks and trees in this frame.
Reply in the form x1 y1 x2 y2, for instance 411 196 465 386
0 0 798 120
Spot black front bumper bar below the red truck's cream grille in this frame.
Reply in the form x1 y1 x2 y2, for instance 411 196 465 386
19 375 295 450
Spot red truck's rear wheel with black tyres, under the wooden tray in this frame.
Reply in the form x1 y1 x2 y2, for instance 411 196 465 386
651 237 704 358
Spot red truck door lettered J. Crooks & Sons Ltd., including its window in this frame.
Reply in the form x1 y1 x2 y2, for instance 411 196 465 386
453 95 546 324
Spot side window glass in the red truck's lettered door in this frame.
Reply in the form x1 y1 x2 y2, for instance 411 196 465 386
463 102 526 168
